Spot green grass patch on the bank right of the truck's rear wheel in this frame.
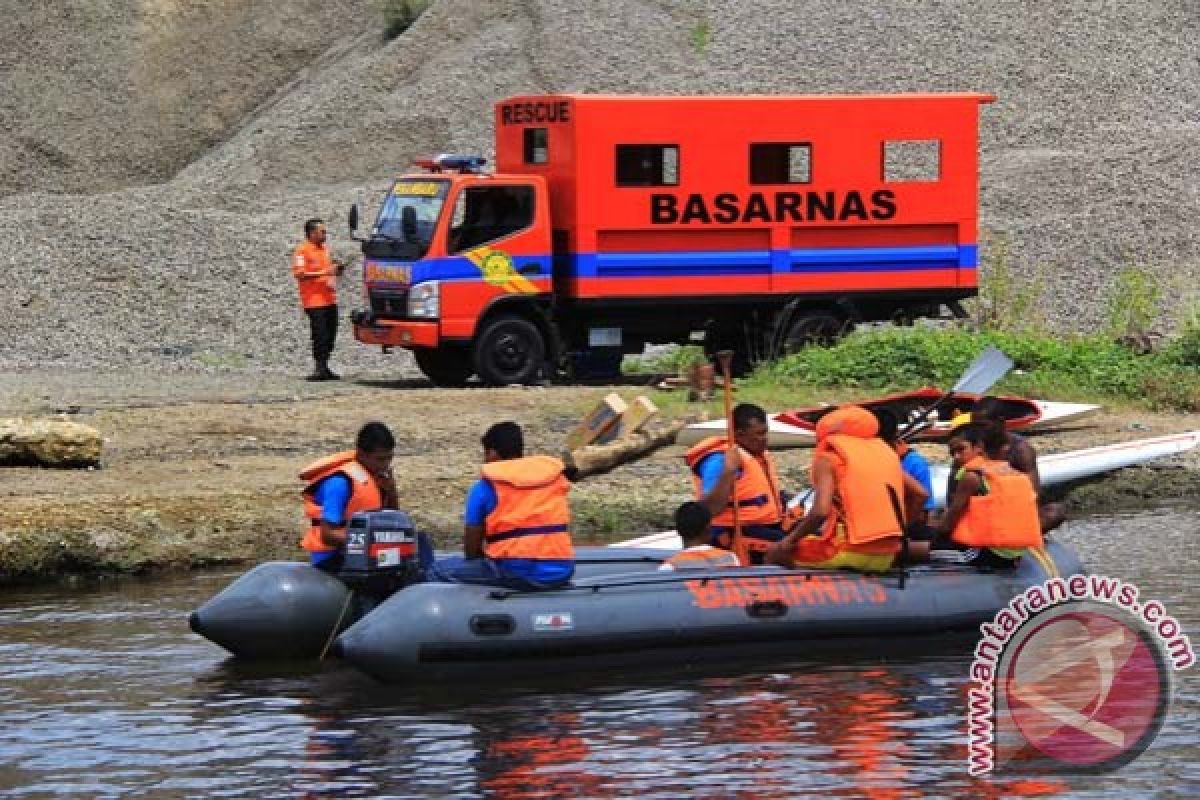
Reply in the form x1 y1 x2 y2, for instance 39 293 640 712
739 327 1200 411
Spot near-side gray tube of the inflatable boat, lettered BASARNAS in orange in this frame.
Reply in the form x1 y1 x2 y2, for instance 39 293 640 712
334 543 1082 682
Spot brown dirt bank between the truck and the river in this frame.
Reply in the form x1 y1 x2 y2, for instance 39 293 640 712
0 372 1200 583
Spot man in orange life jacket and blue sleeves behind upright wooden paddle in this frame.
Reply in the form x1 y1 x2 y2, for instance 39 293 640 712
684 403 785 564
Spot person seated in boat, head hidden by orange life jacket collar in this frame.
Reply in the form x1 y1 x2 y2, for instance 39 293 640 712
767 405 929 572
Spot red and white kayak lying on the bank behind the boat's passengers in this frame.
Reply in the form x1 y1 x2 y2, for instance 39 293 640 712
676 387 1100 450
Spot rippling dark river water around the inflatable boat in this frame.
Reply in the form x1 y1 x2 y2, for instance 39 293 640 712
0 509 1200 799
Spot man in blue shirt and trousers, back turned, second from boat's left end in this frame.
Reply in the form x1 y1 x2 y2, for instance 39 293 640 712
425 422 575 590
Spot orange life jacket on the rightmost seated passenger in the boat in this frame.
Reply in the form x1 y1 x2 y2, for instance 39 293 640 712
950 458 1043 548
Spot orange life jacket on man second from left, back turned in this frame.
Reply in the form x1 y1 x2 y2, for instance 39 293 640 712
482 456 575 560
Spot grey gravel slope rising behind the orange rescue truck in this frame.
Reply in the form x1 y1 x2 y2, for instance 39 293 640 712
0 0 1200 373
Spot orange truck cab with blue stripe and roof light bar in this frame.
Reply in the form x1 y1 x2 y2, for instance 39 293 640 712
352 155 552 385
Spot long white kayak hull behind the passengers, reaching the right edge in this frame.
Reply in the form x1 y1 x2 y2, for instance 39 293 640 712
614 431 1200 549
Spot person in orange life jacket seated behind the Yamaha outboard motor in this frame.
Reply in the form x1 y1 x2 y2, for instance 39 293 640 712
300 422 397 572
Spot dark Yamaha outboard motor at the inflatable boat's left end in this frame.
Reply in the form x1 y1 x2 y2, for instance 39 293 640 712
337 511 421 597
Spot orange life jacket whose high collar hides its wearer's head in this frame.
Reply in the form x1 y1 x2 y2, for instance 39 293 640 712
797 405 904 563
